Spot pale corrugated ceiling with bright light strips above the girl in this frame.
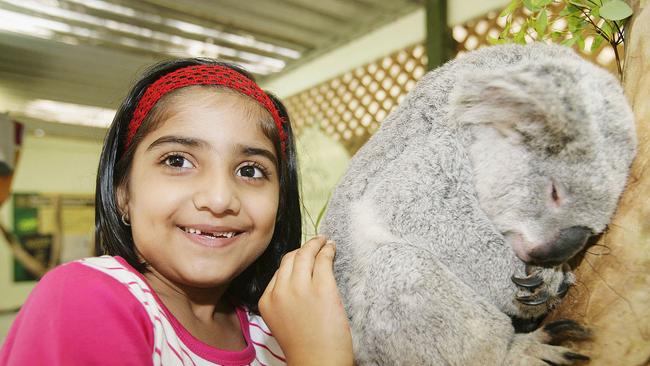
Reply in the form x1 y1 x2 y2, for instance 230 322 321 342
0 0 423 137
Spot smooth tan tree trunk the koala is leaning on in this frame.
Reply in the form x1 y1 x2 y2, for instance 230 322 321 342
549 0 650 366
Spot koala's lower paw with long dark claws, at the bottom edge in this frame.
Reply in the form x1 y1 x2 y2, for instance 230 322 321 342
503 320 591 366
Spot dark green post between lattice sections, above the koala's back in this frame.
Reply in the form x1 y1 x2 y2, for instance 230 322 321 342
425 0 454 70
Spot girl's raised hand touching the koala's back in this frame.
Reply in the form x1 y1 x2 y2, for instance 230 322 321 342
259 236 353 366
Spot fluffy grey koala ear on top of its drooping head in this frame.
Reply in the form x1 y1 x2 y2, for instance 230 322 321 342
449 63 590 153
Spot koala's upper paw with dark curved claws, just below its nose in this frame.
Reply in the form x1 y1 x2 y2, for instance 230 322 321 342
511 265 575 317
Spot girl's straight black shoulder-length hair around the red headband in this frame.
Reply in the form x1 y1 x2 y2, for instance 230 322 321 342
95 58 302 313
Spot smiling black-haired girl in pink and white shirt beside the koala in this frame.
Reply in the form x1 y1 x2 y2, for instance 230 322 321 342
0 59 352 365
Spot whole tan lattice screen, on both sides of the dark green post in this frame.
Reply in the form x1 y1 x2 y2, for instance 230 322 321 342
285 3 616 155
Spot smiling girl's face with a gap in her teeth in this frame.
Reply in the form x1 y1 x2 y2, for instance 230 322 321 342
118 87 279 288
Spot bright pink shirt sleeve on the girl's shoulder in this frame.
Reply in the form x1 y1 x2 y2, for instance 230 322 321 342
0 263 153 366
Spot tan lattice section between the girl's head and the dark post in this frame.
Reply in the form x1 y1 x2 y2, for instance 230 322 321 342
285 45 427 154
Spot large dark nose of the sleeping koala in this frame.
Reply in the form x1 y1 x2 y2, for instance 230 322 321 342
529 226 593 265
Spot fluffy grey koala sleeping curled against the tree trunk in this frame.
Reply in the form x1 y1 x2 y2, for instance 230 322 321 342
322 44 636 365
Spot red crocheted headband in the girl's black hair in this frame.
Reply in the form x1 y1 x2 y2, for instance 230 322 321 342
124 65 286 153
